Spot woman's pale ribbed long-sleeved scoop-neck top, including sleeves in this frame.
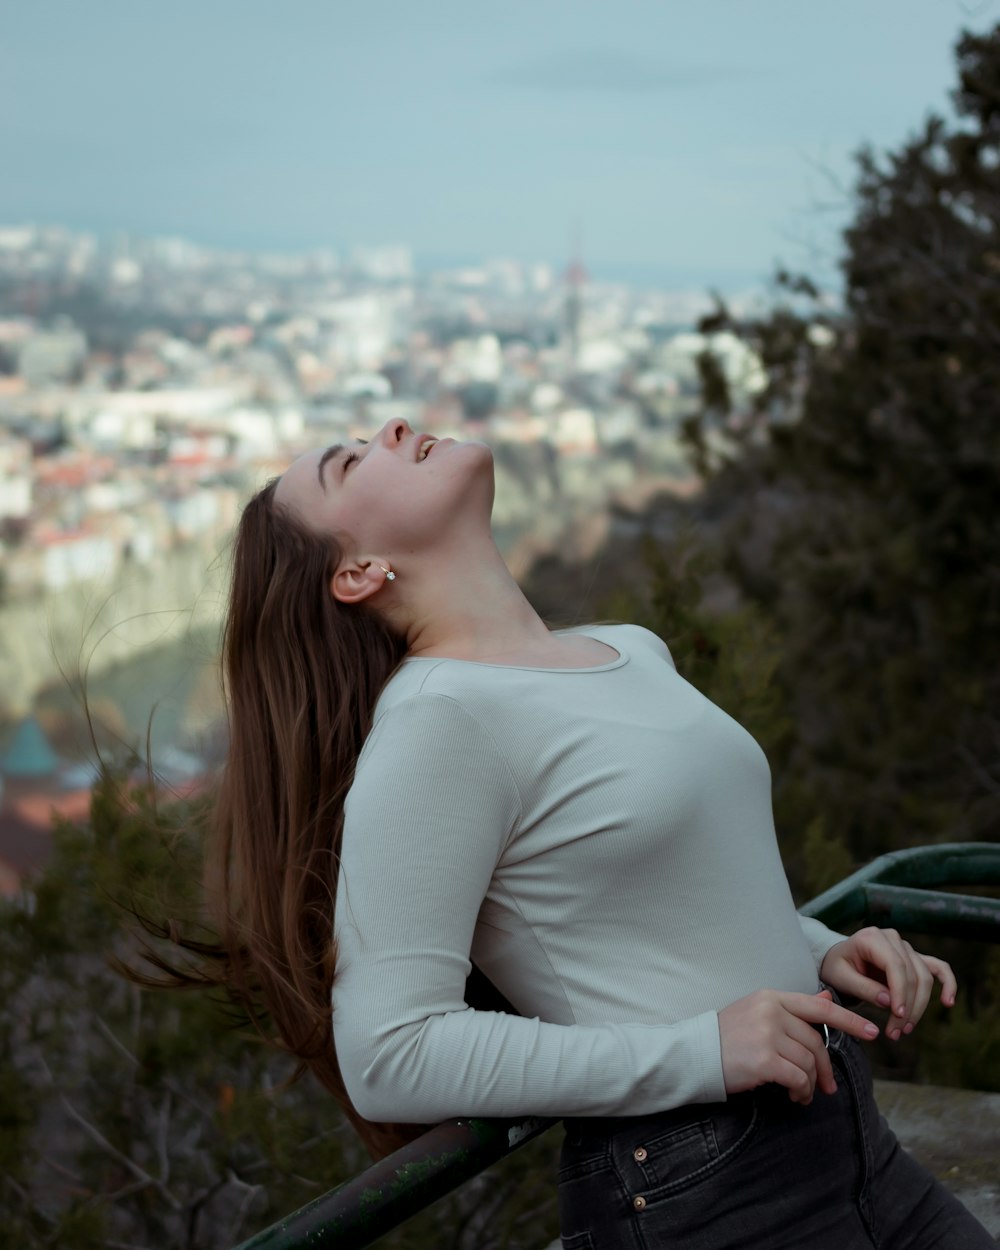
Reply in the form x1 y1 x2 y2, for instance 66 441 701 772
334 625 841 1123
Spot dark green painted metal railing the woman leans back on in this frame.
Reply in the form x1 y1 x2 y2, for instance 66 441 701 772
236 843 1000 1250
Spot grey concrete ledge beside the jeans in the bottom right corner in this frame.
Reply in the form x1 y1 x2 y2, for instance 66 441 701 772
875 1080 1000 1238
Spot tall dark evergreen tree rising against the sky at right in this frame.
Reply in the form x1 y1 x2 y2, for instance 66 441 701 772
685 28 1000 859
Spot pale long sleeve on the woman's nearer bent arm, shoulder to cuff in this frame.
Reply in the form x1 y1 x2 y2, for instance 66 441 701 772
333 694 726 1123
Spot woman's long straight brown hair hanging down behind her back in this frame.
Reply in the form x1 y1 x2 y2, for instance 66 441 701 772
133 480 426 1159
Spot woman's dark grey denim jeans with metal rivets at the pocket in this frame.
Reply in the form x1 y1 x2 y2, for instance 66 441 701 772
559 1031 996 1250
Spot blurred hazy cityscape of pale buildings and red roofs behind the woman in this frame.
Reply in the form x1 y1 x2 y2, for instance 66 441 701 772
0 226 765 890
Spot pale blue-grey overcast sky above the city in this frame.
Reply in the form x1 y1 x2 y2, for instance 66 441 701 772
0 0 1000 285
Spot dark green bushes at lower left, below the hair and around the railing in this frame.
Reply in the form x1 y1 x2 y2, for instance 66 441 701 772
0 774 556 1250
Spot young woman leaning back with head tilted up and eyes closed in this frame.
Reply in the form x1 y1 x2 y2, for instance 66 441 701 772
202 421 993 1250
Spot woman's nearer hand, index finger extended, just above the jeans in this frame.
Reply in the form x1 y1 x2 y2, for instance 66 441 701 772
719 990 879 1106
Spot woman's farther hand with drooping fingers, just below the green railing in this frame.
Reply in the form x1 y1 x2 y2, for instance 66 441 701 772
820 925 958 1041
